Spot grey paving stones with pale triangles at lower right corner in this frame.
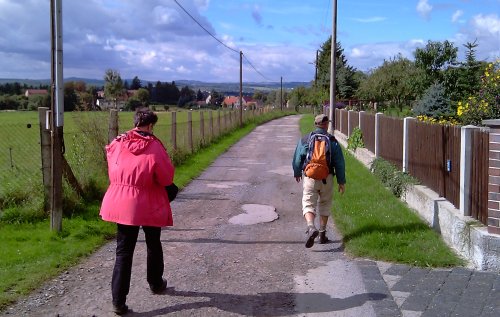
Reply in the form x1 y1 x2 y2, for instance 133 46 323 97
358 261 500 317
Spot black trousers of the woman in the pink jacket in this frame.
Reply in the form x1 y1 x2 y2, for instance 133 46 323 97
111 224 164 305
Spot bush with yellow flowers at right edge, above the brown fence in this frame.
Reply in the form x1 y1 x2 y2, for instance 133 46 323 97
457 59 500 125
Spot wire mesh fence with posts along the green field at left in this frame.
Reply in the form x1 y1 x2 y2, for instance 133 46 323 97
0 107 307 217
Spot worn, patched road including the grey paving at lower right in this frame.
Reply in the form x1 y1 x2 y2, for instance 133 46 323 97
0 116 500 317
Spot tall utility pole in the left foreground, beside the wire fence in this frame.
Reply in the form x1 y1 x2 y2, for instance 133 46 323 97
50 0 64 232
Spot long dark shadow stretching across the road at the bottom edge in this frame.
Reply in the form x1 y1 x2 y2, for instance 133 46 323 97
127 287 387 317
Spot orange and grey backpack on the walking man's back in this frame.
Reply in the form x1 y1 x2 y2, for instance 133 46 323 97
304 133 330 180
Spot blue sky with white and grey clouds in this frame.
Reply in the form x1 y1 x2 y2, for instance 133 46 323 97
0 0 500 82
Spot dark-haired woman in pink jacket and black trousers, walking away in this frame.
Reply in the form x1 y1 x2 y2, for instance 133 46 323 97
100 108 174 315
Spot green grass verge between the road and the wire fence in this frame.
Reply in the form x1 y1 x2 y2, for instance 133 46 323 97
0 112 291 311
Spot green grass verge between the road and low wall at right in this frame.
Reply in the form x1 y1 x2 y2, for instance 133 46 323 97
300 115 464 267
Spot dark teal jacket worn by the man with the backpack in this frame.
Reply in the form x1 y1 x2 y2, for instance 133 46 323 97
292 128 346 184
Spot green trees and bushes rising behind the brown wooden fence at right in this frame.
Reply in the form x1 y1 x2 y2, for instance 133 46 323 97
289 36 500 125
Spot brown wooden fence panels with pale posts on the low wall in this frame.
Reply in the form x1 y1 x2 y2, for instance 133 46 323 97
335 109 489 225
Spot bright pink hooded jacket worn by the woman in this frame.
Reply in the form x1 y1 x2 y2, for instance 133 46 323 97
100 129 174 227
